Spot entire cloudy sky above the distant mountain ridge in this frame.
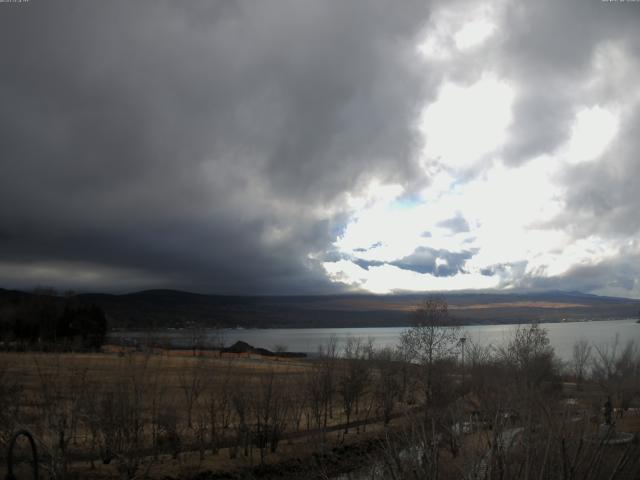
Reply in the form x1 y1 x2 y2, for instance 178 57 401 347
0 0 640 298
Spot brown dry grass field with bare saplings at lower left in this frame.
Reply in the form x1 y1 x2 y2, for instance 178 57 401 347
0 349 408 479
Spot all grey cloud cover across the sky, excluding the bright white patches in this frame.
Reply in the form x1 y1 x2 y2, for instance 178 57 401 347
0 0 640 296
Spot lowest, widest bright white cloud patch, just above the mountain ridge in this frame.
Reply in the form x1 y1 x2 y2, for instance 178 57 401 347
324 148 620 293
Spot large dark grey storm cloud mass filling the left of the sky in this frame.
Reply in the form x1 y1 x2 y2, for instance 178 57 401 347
0 0 428 293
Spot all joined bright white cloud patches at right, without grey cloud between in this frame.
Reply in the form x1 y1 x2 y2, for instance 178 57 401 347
324 2 640 293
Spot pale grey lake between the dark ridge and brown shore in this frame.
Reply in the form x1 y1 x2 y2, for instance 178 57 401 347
109 319 640 360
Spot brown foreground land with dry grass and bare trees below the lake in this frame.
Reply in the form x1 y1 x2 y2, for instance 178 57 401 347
0 300 640 480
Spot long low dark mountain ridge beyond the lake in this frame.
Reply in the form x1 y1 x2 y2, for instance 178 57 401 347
0 289 640 328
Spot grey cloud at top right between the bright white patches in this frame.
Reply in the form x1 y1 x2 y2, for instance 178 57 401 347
494 1 640 164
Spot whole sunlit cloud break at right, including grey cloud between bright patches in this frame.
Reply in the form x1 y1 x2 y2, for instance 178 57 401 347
323 1 640 295
